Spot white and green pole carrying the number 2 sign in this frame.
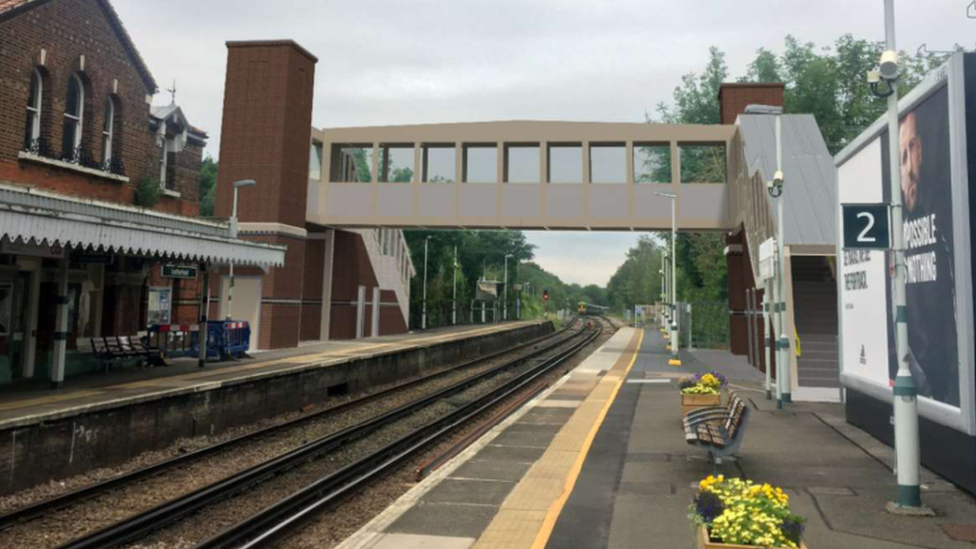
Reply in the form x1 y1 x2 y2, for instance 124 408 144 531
885 0 922 510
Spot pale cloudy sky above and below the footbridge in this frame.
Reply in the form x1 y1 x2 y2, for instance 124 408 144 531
113 0 976 285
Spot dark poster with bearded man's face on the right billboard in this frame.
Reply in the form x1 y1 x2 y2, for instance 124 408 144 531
885 87 959 406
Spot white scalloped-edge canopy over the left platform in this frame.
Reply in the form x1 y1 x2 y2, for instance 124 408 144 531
0 182 285 267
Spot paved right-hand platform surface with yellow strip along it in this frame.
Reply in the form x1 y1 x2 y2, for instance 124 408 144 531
338 328 976 549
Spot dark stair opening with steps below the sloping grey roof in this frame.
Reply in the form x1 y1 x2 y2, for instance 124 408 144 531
791 257 840 388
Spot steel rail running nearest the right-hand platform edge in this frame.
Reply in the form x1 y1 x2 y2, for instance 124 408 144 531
193 327 603 549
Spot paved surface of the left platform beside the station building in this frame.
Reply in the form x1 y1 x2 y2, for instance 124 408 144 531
0 321 536 429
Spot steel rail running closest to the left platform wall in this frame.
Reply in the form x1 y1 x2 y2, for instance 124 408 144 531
0 323 572 531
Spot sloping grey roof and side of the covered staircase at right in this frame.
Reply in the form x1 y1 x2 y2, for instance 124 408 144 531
737 114 837 245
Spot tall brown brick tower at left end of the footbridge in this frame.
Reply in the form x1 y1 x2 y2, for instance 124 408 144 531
216 40 318 349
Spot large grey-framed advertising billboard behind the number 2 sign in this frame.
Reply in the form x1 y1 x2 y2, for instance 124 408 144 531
835 54 976 435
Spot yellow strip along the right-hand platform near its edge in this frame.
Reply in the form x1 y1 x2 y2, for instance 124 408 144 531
474 330 644 549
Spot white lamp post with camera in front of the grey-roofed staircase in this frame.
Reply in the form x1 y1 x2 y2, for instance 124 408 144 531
766 108 793 408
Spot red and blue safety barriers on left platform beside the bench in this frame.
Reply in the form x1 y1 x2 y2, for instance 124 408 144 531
146 320 251 360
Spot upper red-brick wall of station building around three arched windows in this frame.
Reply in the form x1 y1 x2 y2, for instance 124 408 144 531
0 0 199 215
